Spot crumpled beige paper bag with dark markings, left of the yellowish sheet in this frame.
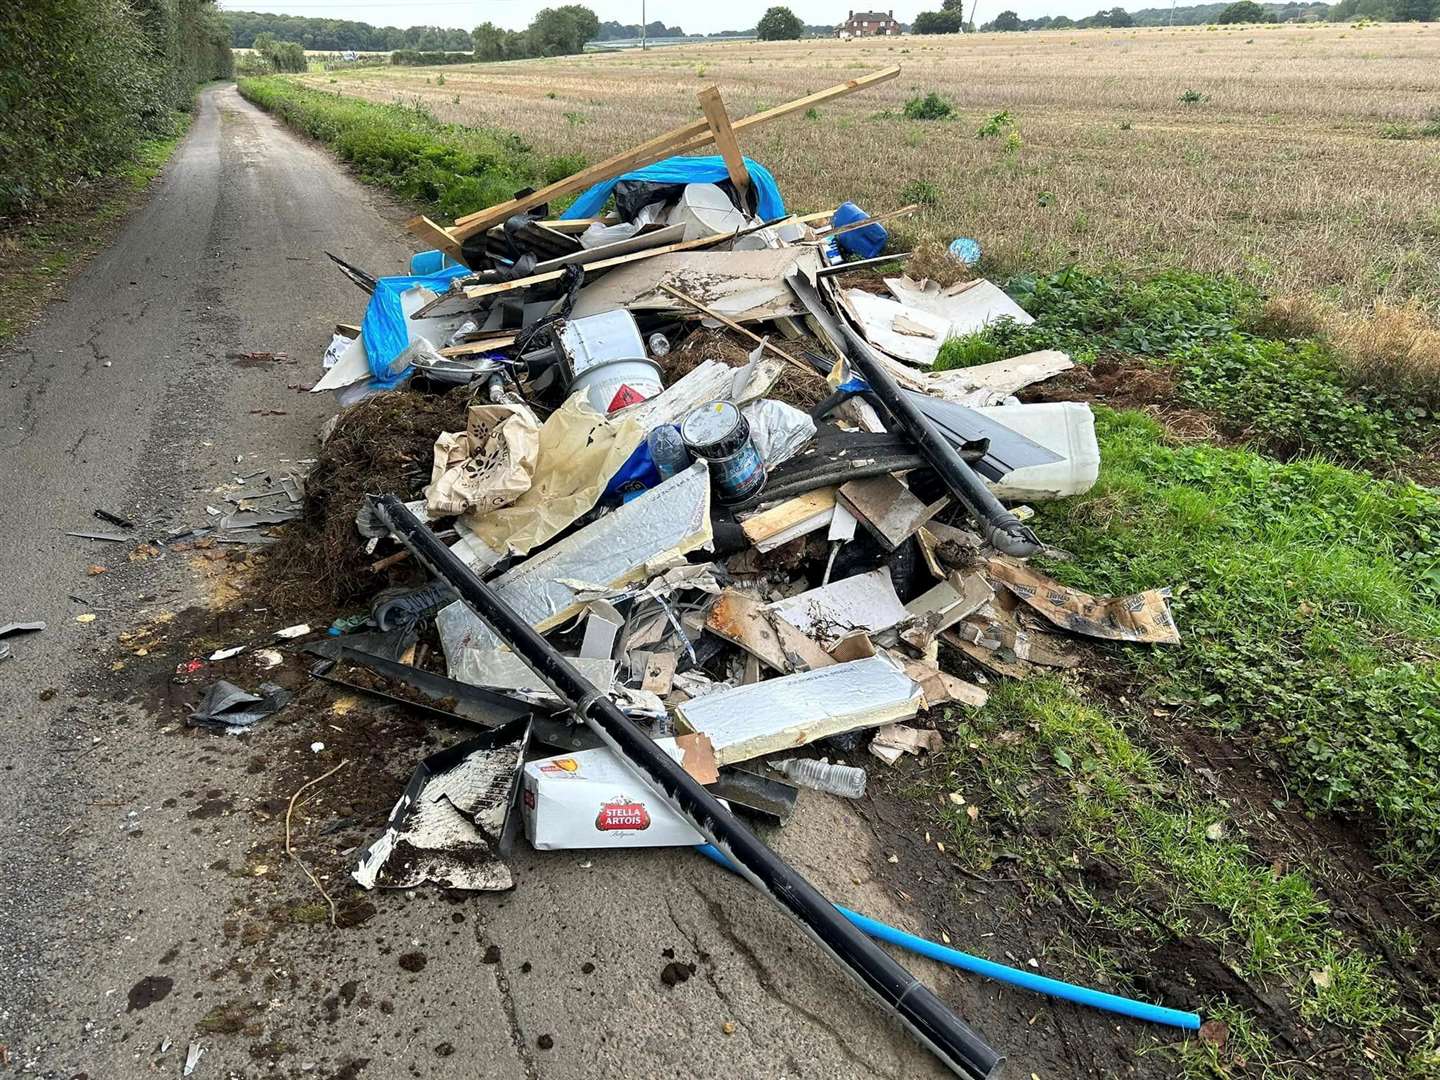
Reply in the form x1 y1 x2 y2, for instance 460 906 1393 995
425 403 540 517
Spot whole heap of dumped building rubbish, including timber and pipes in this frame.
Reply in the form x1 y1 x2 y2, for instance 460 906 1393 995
218 69 1198 1077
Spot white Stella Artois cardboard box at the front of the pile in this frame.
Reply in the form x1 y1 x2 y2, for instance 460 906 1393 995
520 739 713 851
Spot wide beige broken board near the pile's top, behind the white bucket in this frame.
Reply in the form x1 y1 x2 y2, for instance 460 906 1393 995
570 248 819 323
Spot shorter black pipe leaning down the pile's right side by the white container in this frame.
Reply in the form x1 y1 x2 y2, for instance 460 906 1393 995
840 320 1044 559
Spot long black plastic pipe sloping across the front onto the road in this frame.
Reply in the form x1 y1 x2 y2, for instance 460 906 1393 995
376 495 1002 1080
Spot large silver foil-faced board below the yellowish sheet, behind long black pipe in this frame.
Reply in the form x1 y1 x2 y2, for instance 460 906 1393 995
435 462 711 668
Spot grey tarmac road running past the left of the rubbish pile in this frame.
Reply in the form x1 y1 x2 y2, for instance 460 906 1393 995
0 86 979 1080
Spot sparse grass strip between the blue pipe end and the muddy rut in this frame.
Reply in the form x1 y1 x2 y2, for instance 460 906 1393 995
924 677 1423 1077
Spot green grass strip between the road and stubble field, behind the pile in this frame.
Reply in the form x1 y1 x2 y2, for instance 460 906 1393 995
239 76 585 219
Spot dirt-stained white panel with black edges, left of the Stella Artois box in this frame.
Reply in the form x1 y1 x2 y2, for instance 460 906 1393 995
350 719 528 890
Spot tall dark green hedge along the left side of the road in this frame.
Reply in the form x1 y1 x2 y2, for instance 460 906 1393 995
0 0 232 217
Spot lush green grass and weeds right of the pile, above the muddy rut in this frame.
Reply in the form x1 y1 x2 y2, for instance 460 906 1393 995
1038 409 1440 874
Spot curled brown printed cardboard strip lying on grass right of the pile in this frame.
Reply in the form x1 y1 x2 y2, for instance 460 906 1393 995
986 559 1179 645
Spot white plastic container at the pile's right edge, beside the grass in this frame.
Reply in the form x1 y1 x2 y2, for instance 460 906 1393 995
975 402 1100 503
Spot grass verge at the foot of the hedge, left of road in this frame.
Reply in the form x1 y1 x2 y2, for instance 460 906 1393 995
0 112 190 347
